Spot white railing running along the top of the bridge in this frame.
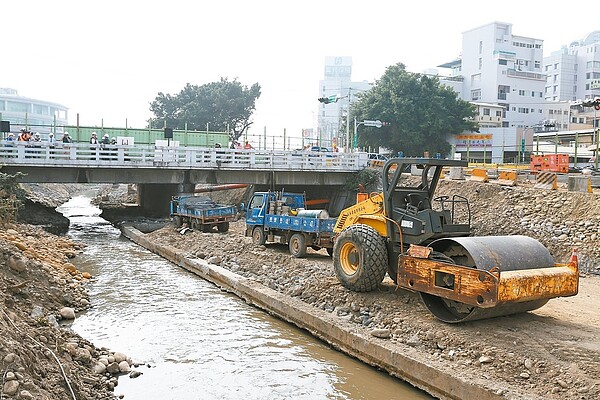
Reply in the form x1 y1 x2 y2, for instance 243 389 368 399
0 141 369 171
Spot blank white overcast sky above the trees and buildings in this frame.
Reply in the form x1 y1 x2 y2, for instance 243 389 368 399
0 0 600 141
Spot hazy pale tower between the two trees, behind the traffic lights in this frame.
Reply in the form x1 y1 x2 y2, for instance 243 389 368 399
312 57 371 147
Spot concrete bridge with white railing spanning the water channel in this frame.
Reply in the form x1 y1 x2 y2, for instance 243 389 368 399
0 141 369 214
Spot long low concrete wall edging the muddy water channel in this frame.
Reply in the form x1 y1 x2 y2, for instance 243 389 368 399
121 226 506 400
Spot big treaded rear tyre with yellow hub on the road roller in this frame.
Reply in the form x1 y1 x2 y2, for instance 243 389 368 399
333 224 388 292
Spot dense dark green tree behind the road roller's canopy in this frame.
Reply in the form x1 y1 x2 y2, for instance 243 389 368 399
351 63 478 156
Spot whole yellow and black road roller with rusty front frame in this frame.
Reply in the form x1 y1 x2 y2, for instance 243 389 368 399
333 158 579 323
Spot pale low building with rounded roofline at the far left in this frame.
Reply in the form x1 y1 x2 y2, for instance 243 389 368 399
0 88 68 134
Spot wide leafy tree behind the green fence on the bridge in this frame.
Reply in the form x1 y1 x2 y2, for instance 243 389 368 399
148 78 260 141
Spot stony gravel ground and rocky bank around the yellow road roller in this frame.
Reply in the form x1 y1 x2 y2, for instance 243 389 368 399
144 181 600 400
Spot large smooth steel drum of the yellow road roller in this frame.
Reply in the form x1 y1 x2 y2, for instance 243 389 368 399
420 235 554 323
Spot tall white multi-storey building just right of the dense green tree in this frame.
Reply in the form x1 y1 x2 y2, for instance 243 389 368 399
440 22 546 128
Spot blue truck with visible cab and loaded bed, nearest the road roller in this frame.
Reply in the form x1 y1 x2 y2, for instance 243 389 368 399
246 191 337 258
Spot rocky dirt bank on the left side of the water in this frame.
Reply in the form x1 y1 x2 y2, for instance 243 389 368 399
0 225 122 400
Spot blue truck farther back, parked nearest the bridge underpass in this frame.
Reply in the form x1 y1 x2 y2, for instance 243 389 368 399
170 194 239 232
